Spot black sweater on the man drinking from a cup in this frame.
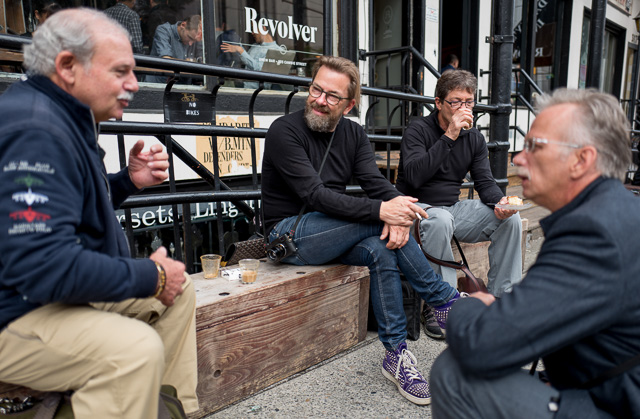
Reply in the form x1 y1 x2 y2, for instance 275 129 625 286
396 111 504 206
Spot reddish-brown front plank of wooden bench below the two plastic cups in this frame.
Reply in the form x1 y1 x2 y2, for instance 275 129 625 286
194 277 369 417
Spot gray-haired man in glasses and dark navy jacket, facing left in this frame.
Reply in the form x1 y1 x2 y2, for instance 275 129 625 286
431 90 640 419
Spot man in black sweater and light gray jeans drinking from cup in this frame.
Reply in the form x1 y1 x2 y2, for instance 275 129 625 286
396 70 522 339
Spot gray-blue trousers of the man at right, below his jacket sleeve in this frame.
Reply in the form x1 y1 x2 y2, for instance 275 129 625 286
430 350 560 419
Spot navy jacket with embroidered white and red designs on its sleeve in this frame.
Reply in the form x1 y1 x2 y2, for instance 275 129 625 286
0 76 158 330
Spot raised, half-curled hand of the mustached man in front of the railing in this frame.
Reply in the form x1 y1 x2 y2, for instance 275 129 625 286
129 140 169 189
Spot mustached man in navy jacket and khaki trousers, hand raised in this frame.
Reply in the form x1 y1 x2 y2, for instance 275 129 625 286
0 9 198 418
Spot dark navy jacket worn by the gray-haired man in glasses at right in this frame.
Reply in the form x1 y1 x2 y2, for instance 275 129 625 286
447 178 640 418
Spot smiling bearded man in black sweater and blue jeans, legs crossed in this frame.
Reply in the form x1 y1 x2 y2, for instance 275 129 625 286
262 57 460 405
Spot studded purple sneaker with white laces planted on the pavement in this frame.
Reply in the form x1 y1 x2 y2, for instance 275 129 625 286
382 342 431 405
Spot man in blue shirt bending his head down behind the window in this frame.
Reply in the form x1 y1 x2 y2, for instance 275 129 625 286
145 15 202 83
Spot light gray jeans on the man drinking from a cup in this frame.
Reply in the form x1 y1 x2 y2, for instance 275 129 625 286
419 199 522 297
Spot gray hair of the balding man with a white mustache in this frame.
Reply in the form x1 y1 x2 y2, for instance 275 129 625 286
24 8 131 77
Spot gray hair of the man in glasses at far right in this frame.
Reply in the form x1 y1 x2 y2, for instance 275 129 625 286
536 88 631 179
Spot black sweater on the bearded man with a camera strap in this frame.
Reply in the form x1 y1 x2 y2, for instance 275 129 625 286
262 111 401 233
